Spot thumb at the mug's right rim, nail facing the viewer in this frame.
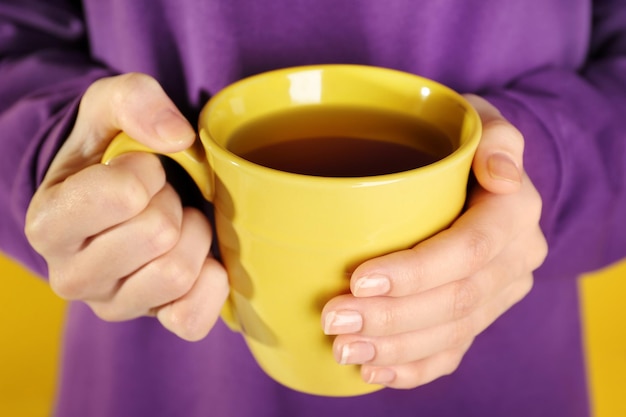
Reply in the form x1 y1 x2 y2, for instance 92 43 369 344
465 94 524 194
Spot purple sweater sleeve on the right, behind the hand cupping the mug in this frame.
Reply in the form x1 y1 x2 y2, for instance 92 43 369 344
486 0 626 276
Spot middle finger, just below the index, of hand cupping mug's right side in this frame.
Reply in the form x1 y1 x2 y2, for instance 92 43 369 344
322 223 545 337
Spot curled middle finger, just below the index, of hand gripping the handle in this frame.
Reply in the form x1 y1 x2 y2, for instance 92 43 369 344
51 185 183 301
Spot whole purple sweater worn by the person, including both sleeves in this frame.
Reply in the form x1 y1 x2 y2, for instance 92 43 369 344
0 0 626 417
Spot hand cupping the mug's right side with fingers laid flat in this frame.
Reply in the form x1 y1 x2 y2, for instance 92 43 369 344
322 96 547 388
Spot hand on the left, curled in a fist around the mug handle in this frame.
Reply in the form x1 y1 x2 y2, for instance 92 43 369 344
26 73 228 340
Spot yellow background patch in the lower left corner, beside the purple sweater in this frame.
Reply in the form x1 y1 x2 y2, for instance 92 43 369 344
0 256 65 417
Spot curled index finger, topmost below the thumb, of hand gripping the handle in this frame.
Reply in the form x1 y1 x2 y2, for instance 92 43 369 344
25 154 166 256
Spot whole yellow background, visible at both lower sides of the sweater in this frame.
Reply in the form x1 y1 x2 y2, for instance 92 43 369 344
0 252 626 417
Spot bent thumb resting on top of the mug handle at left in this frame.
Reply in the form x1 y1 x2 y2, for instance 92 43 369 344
70 73 196 154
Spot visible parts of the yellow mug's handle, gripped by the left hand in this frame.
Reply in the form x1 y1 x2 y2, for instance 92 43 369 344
101 132 241 331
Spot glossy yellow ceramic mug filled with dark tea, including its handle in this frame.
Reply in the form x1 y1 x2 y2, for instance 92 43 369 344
103 65 481 396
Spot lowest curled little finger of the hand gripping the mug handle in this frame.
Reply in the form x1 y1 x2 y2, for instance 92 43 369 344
156 254 229 341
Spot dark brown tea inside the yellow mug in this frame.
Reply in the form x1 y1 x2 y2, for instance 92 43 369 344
229 106 453 177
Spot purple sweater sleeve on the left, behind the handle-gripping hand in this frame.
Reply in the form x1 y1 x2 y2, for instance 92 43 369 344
0 0 109 276
